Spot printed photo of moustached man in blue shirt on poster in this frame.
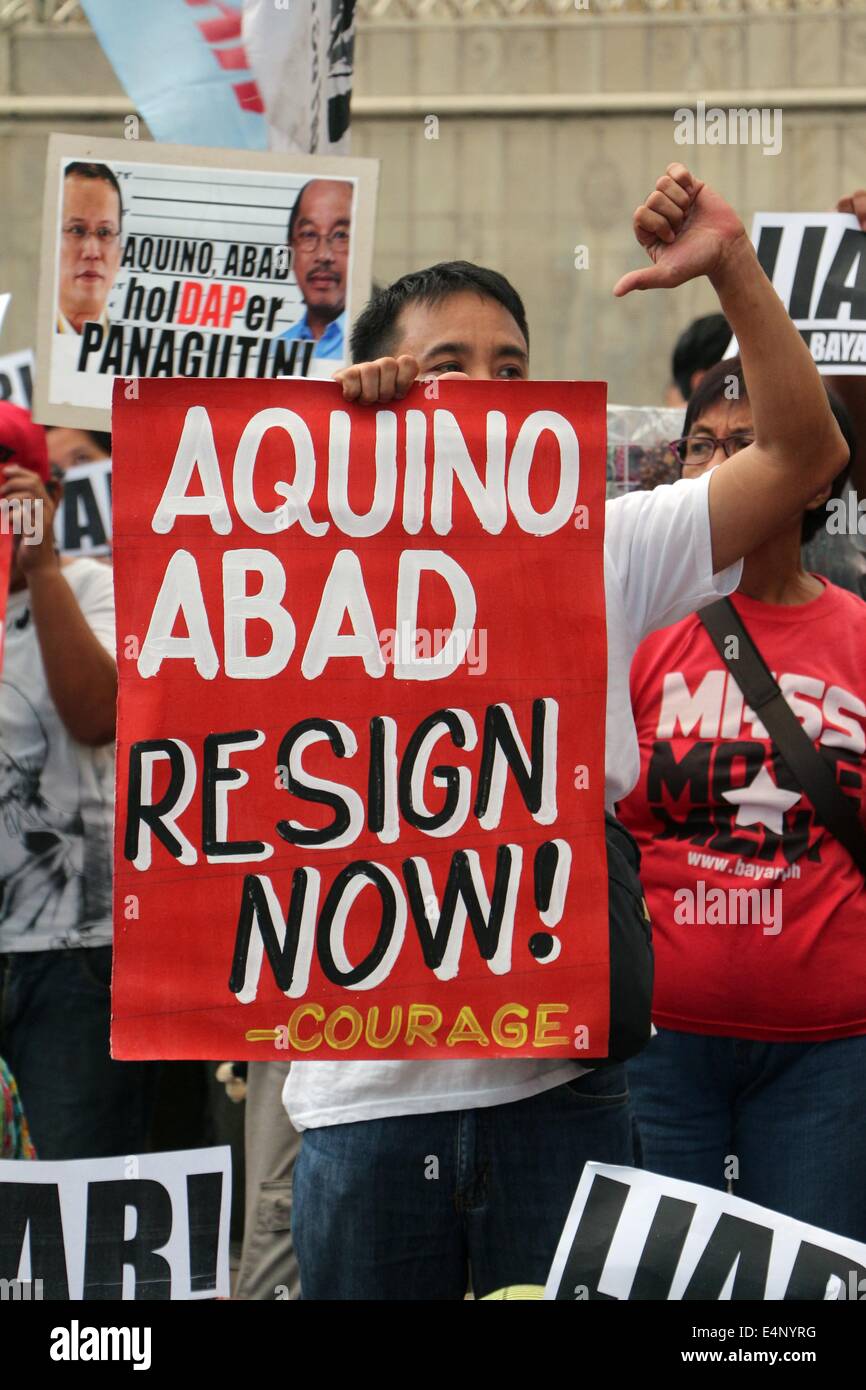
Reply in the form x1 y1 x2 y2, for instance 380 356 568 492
282 178 353 360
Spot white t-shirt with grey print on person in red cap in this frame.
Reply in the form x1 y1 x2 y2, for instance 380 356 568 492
0 560 114 951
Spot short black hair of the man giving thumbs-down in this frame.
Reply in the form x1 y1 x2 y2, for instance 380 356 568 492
352 261 530 361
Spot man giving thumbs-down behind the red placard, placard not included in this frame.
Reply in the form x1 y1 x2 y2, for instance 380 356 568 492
284 164 847 1300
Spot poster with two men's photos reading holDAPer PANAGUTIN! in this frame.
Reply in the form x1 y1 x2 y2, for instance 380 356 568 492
35 135 378 430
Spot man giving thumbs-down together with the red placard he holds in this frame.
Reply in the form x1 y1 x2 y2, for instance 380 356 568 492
108 165 844 1298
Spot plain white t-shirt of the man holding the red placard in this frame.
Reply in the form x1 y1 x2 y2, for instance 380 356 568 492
282 471 742 1130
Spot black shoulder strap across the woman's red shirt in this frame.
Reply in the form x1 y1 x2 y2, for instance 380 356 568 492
698 599 866 876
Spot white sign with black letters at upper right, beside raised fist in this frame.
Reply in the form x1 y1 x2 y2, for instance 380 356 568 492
726 213 866 377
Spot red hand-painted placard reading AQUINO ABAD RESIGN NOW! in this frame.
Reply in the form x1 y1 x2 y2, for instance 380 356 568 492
113 381 609 1059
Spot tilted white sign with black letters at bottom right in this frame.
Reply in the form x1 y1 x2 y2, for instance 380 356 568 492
545 1163 866 1302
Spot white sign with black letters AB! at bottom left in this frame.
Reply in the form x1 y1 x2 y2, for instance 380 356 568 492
0 1147 231 1301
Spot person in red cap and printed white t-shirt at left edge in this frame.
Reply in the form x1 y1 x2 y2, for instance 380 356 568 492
0 402 154 1159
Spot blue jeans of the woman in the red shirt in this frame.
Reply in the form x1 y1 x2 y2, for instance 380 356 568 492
628 1029 866 1240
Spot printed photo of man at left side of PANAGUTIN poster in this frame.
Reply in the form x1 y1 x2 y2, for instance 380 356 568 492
56 160 122 334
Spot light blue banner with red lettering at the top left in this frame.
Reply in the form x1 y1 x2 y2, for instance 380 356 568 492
81 0 268 150
